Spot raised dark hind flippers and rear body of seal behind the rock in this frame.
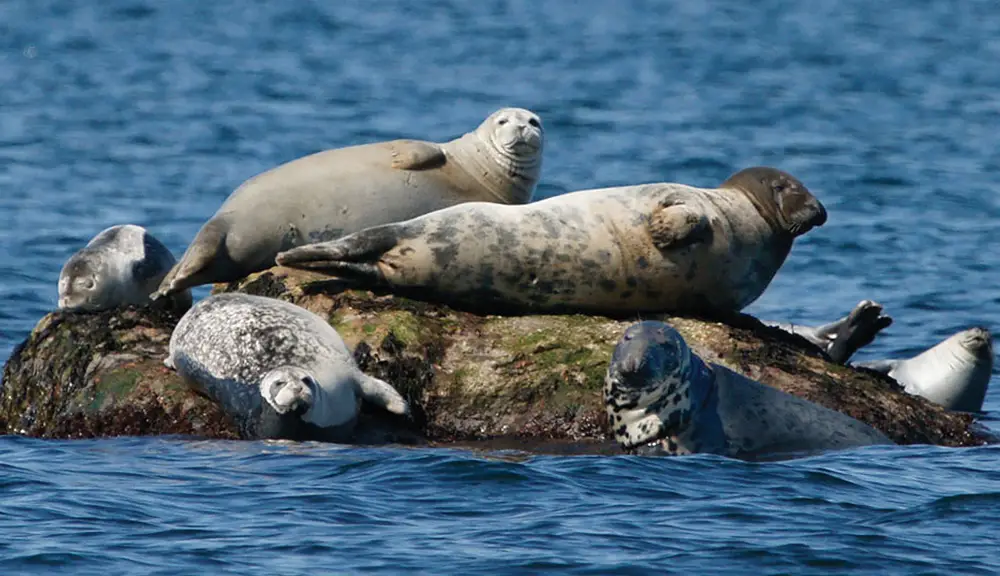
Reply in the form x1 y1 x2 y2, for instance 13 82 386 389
764 300 892 364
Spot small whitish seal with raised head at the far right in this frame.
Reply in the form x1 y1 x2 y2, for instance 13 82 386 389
852 326 993 412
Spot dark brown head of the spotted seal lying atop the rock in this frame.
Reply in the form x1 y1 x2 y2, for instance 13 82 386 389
720 166 826 238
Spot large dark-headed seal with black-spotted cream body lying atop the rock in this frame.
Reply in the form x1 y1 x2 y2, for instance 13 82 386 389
277 167 826 316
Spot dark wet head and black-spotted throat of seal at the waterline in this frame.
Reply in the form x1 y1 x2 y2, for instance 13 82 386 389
604 321 711 450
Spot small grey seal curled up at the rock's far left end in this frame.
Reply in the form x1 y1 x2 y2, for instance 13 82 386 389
58 224 191 313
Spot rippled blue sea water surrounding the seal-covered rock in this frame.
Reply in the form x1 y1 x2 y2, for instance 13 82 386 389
0 0 1000 574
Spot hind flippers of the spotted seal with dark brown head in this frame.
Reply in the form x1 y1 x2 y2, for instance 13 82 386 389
274 224 399 284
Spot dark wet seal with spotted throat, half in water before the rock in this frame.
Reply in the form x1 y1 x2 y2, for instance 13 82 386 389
604 321 893 460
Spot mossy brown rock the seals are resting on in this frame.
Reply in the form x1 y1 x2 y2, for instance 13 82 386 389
0 268 994 453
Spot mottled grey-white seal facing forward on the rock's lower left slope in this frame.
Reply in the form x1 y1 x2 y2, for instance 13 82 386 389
165 294 409 442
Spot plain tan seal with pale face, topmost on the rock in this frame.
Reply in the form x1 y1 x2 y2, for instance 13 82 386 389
157 108 543 297
